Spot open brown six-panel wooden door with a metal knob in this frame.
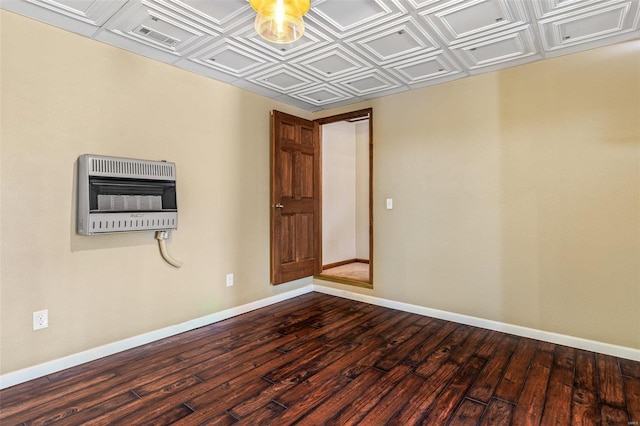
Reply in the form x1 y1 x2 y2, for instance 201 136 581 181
271 111 322 284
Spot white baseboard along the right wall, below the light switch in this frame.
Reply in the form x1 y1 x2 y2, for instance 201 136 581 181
313 284 640 361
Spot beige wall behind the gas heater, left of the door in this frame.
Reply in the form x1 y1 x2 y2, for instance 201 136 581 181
0 11 311 373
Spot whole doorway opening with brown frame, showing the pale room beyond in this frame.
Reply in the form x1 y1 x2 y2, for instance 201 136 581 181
317 108 373 288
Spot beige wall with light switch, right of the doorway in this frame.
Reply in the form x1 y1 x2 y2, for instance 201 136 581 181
317 41 640 349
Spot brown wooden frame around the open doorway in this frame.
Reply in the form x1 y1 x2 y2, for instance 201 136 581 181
314 108 373 288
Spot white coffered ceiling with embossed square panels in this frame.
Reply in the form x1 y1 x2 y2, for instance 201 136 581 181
5 0 640 111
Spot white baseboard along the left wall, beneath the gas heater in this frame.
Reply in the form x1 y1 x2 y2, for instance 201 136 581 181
0 284 313 389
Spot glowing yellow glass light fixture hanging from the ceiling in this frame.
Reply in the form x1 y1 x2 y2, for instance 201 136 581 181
249 0 311 43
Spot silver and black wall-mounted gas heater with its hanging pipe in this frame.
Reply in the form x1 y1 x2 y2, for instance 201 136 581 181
78 154 180 267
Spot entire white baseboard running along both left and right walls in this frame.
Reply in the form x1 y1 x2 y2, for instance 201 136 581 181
0 284 640 389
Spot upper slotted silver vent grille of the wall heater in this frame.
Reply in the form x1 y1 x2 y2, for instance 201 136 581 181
89 157 175 180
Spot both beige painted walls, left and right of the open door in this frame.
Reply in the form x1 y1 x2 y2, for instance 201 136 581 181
0 11 640 373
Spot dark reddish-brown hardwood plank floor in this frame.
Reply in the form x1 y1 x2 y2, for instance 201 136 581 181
0 293 640 426
